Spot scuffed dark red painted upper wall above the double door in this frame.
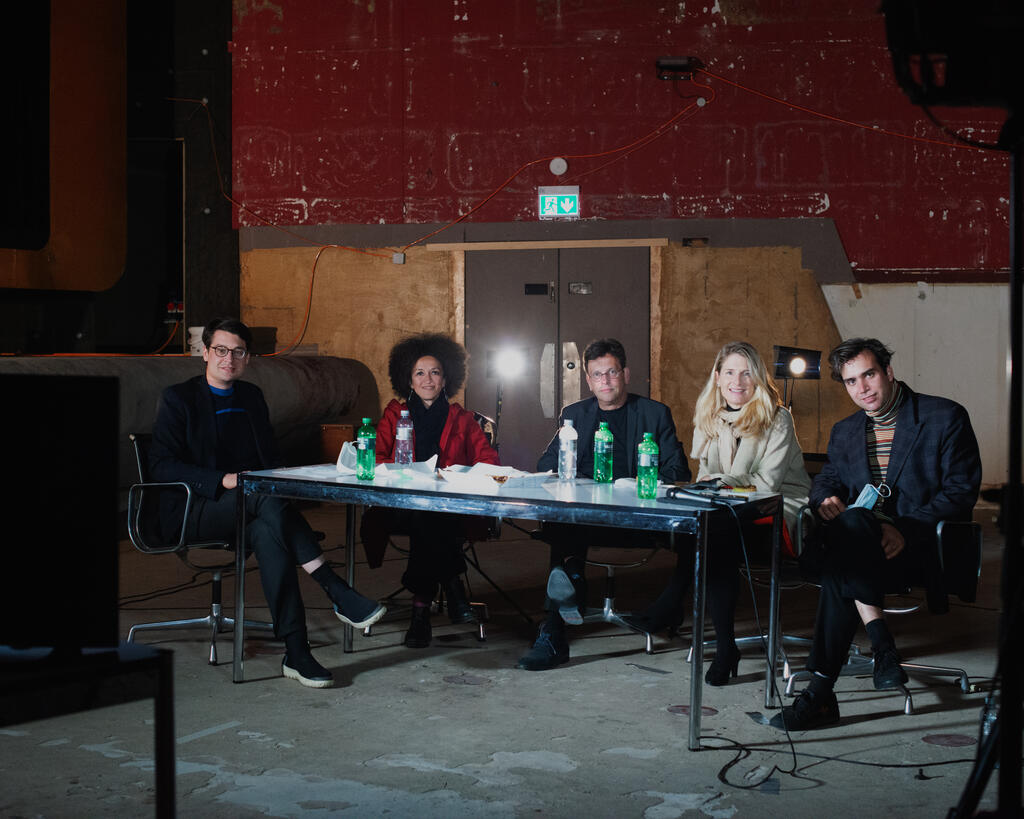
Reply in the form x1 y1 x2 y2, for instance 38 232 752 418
232 0 1010 281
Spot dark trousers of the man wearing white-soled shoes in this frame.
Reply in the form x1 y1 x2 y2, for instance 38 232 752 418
186 489 322 640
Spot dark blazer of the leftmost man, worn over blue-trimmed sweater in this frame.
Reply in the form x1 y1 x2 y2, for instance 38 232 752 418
150 375 280 530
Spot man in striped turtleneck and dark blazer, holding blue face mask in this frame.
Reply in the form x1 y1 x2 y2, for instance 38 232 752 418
772 339 981 731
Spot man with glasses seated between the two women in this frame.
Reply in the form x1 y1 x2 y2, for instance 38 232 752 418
519 338 690 671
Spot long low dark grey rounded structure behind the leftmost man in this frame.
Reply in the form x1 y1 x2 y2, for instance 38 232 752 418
0 356 368 487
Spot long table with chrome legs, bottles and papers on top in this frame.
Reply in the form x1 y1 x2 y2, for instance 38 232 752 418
232 464 782 750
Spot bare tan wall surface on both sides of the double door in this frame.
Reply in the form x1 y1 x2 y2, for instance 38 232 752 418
242 243 853 466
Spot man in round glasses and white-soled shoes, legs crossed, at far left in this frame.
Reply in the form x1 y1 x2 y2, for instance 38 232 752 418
150 318 385 688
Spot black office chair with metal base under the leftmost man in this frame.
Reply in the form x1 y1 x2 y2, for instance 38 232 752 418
128 432 273 665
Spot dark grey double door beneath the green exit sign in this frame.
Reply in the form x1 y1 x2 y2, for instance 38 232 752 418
465 247 650 471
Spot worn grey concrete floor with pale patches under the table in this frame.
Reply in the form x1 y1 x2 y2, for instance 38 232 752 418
0 506 1001 819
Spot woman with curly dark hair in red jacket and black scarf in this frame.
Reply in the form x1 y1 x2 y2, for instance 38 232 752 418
361 333 499 648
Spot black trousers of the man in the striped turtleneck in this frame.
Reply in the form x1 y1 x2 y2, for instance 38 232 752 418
807 508 935 680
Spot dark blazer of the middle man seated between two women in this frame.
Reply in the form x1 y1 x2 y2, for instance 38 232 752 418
537 393 690 483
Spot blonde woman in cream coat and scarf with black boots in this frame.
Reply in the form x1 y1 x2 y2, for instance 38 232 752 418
690 341 811 685
